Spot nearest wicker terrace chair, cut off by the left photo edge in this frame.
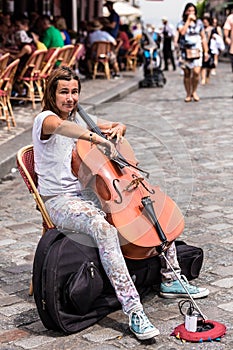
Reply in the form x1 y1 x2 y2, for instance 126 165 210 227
0 58 19 131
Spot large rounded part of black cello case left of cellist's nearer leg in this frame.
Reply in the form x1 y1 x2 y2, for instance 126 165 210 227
33 229 120 334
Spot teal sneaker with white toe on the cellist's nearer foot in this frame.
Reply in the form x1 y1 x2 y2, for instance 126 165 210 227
129 310 160 340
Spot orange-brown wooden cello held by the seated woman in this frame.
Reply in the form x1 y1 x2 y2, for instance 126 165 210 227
71 105 184 259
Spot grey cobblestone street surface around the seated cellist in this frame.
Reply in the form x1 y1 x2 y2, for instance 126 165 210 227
0 63 233 350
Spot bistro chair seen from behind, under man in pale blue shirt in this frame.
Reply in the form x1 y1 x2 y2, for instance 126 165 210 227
91 41 112 79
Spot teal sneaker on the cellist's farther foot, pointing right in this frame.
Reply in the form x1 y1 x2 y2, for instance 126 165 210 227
159 275 209 299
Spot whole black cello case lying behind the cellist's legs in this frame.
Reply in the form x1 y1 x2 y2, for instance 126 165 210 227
33 229 203 334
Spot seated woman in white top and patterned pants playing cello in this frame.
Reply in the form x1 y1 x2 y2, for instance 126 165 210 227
32 66 209 340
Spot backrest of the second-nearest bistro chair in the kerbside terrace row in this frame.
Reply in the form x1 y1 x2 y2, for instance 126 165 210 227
19 50 47 79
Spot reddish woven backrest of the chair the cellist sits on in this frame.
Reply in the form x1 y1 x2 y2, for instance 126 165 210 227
16 145 54 229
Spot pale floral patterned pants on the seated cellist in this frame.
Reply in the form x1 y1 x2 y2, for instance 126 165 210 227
45 191 180 315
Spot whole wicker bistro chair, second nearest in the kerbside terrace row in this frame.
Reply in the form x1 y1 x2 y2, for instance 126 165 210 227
11 50 47 109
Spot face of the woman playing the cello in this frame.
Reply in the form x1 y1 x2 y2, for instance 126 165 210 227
56 79 79 119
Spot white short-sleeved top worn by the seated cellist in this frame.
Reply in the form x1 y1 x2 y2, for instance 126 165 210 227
32 111 96 196
